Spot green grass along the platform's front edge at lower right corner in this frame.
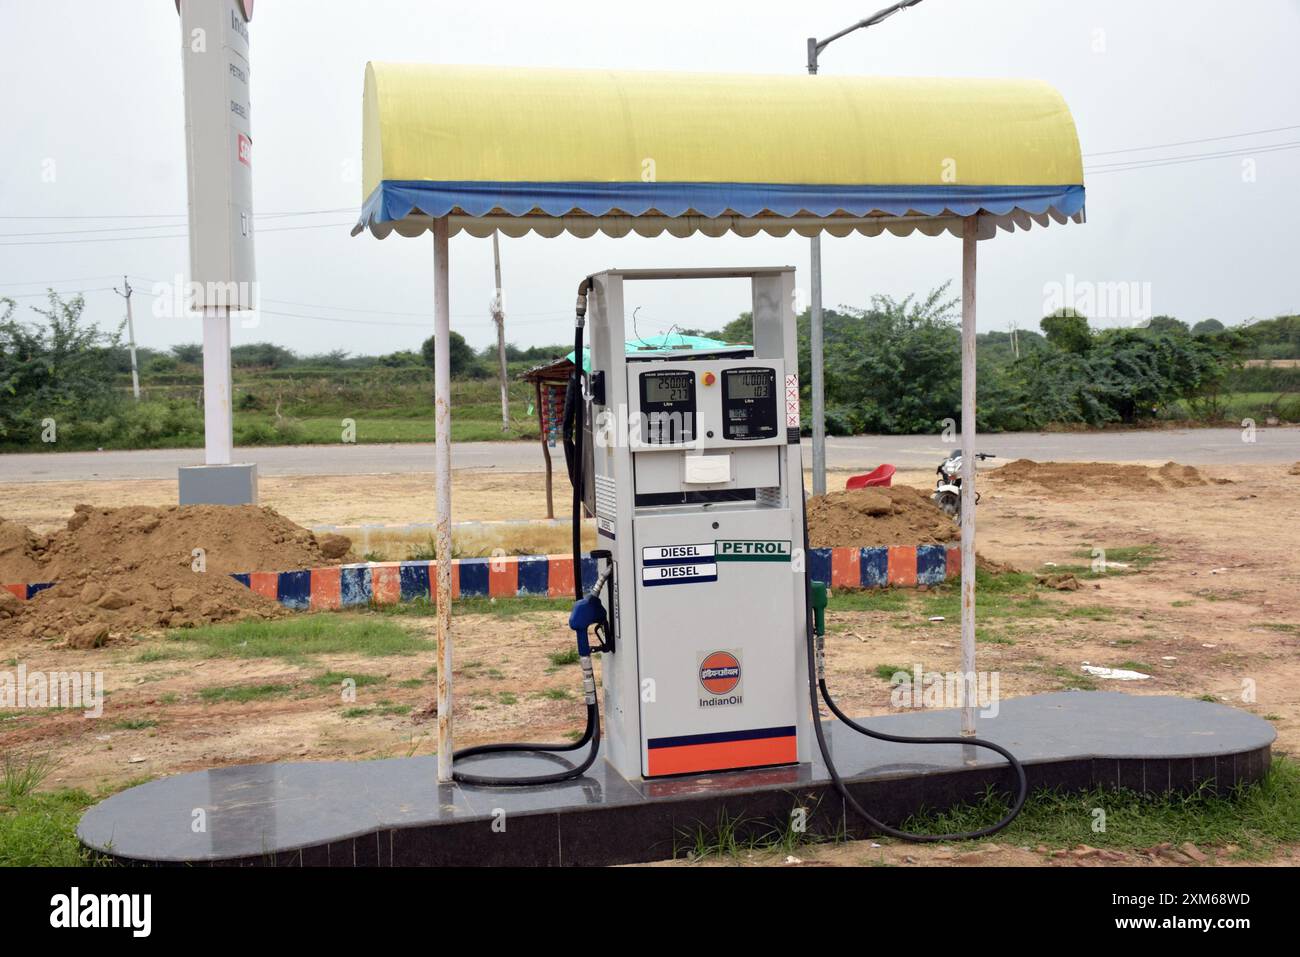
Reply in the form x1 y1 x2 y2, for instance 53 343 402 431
904 757 1300 859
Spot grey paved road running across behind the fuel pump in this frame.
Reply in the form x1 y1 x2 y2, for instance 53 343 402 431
0 428 1300 482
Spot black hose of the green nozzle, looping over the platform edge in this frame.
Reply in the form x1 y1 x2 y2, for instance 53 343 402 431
801 489 1030 844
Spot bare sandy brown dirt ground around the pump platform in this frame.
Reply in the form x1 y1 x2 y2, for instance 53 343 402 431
0 465 1300 866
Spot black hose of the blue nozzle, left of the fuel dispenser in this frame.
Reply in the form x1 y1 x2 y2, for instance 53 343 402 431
451 280 601 788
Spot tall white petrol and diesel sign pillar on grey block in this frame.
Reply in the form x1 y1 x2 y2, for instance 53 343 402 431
177 0 257 505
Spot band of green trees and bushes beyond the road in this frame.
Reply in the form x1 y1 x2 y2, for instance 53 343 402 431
0 283 1300 450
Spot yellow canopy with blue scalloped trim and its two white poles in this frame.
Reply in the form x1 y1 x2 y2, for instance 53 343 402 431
354 64 1083 781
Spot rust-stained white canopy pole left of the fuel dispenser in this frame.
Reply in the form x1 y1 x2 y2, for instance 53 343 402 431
433 217 452 783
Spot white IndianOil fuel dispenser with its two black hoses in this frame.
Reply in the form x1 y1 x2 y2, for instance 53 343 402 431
454 267 1027 841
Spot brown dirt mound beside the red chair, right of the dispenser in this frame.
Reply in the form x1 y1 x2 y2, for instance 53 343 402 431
809 485 959 549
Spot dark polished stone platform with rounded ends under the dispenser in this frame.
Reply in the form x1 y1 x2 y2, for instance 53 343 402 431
77 692 1275 867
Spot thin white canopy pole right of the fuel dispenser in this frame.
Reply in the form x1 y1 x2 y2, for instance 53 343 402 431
962 216 979 736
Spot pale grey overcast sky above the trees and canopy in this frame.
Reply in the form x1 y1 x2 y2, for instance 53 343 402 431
0 0 1300 354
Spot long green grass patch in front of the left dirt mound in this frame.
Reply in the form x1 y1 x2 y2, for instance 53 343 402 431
168 612 432 662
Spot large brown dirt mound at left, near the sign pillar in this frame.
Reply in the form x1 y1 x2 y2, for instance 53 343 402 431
0 506 348 648
